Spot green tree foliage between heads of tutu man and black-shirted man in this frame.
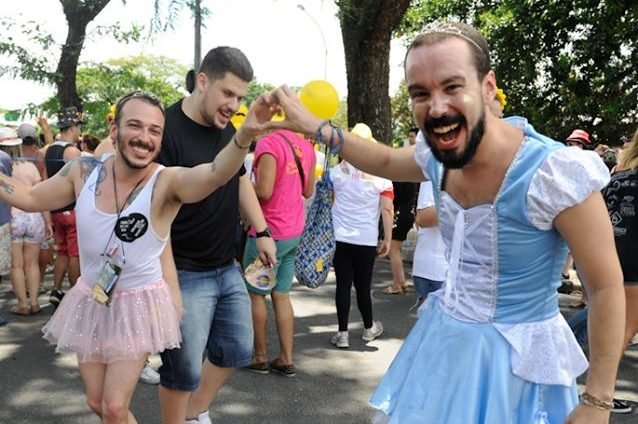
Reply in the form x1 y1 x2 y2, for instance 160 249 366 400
39 56 187 137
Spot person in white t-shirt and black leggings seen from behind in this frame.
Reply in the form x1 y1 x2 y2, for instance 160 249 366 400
330 123 394 348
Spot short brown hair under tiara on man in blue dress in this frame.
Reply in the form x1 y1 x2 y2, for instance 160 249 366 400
405 21 492 80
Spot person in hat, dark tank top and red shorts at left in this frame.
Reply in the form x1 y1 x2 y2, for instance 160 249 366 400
44 107 82 307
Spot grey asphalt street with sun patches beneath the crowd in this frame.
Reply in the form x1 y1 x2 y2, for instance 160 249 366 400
0 260 638 424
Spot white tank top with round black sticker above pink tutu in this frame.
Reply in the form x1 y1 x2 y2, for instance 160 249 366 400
75 158 168 290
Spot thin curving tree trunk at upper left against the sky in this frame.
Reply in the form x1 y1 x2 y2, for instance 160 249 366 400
56 0 110 111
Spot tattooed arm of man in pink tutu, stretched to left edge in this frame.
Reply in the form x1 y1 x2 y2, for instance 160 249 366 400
0 161 80 212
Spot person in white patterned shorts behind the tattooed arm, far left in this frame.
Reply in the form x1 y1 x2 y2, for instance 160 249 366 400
0 124 53 315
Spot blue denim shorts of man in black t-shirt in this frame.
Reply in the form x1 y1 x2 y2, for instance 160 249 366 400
159 263 253 392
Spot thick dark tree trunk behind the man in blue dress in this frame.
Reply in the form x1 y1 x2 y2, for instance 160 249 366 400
337 0 410 144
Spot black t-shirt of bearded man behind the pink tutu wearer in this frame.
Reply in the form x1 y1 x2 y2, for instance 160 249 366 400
157 100 246 271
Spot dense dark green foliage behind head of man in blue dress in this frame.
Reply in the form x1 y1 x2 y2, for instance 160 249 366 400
397 0 638 145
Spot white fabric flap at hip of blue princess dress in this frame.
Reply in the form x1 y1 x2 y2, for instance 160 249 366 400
494 314 589 387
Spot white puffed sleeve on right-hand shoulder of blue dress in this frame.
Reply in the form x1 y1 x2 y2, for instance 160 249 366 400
527 147 609 230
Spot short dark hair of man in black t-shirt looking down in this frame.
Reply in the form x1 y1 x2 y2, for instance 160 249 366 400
199 46 254 82
